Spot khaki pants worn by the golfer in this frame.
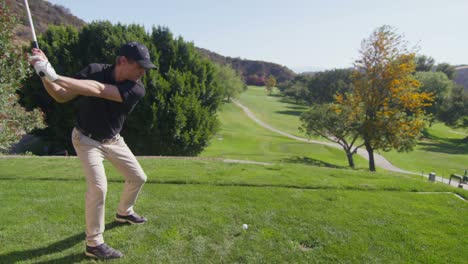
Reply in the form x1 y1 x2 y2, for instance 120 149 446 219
72 129 146 247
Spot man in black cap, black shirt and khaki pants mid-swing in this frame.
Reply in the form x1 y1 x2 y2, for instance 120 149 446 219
30 42 156 259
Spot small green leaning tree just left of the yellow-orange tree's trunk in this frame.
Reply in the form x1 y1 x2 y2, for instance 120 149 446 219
300 104 362 168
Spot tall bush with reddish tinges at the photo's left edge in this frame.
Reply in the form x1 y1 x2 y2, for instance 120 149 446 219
0 1 44 153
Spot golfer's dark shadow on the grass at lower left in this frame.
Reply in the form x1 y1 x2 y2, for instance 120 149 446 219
0 221 125 263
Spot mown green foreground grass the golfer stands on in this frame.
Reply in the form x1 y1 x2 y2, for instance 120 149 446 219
0 157 468 263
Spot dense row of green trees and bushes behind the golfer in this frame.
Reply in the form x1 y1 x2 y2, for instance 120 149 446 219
0 1 245 155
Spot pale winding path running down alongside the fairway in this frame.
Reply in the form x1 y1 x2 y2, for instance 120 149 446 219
233 100 468 189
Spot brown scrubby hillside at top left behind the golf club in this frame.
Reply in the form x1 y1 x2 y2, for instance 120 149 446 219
6 0 85 43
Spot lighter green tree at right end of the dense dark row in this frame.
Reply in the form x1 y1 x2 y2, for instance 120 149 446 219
215 64 246 102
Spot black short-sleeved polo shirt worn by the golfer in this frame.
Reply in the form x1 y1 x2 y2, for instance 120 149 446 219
75 63 145 140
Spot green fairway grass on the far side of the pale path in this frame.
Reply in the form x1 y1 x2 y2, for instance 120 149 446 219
239 86 468 178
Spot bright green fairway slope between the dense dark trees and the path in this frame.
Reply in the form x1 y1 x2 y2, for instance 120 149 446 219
200 104 367 168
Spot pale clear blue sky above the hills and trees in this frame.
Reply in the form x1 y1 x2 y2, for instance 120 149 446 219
45 0 468 71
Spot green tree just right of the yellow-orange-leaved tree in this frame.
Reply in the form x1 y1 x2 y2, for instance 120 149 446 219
415 72 455 123
